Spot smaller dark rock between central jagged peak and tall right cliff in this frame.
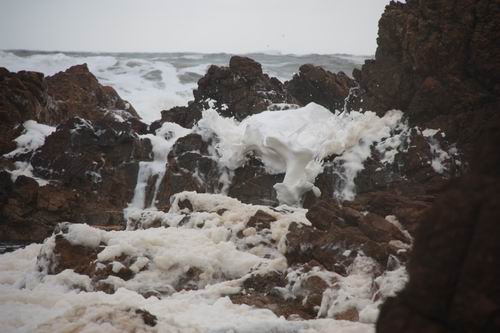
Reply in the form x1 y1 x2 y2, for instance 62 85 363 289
285 64 356 111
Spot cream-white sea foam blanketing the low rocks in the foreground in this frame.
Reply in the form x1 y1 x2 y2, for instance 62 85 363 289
0 192 406 333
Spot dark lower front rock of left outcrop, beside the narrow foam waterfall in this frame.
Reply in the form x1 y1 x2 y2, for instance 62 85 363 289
0 118 151 241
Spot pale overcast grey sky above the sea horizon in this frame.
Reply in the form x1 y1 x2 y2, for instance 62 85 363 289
0 0 389 54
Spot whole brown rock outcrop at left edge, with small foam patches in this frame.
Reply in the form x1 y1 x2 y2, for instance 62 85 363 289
0 65 151 241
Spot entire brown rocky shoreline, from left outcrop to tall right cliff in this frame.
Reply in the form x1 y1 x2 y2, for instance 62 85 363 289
0 0 500 332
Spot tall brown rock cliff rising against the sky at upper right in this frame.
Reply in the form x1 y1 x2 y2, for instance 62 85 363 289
354 0 500 157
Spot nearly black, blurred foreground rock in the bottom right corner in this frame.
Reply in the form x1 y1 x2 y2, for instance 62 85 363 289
377 117 500 332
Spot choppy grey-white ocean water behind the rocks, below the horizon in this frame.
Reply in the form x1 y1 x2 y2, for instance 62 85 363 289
0 51 369 123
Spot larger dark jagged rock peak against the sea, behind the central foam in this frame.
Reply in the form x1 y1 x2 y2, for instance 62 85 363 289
193 56 295 120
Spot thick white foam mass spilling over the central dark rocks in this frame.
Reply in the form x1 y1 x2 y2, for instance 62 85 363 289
198 103 405 205
